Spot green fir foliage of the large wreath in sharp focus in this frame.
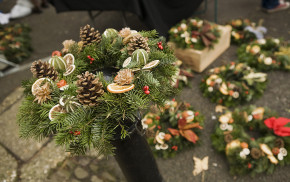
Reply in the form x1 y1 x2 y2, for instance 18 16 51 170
18 27 176 155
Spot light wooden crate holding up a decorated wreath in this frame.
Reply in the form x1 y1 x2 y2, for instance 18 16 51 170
168 26 232 73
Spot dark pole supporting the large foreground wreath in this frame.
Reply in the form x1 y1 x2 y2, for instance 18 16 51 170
112 117 163 182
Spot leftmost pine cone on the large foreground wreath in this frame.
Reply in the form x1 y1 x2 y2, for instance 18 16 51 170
30 60 58 80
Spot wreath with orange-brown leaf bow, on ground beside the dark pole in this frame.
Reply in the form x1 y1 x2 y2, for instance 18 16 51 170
142 100 204 158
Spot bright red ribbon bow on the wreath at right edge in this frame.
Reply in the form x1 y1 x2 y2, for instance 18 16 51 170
264 117 290 137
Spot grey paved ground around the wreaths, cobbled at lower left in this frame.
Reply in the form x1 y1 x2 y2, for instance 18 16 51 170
0 0 290 182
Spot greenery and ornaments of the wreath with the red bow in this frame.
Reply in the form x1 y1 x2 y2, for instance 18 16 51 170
211 105 290 177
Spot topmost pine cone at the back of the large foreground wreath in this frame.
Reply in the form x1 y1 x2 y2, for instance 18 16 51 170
80 25 102 47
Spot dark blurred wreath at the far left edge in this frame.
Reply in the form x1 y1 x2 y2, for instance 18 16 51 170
0 24 32 63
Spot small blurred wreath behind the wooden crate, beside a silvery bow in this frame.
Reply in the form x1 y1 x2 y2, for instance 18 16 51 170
228 19 257 45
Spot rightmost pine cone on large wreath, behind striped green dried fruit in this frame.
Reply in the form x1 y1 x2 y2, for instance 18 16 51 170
127 34 150 55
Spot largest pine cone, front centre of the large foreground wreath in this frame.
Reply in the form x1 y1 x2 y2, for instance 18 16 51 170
77 71 104 106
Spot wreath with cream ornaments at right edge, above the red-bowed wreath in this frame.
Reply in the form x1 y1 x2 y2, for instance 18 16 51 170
238 38 290 71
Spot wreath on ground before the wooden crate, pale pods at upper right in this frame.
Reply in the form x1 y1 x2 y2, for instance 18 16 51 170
200 62 267 106
